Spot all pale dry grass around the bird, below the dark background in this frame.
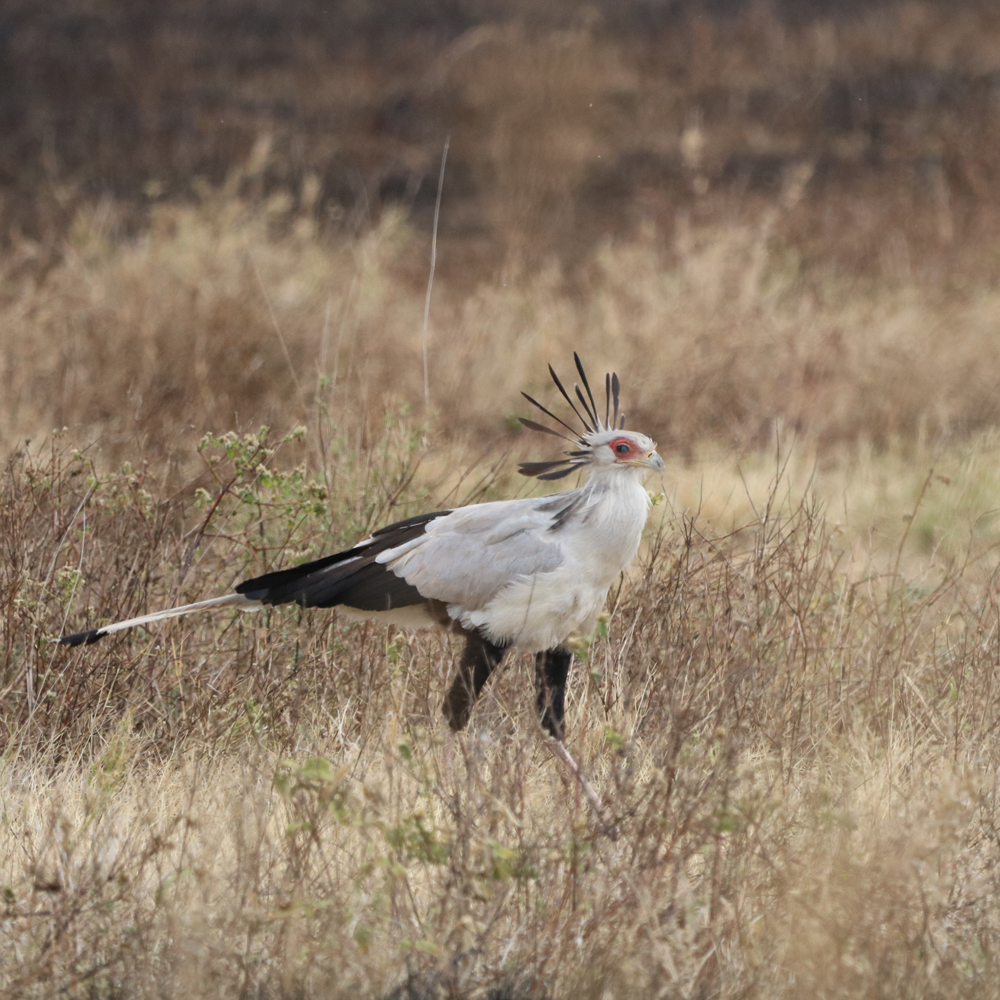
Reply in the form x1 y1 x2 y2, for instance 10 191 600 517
0 182 1000 1000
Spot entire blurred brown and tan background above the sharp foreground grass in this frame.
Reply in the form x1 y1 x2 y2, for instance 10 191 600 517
0 0 1000 467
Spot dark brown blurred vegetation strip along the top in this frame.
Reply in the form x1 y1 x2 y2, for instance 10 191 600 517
7 0 1000 277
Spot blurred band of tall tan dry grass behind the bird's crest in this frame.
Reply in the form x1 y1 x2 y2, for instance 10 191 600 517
0 175 1000 481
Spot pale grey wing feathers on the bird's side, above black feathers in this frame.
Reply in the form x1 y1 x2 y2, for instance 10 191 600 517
378 497 565 611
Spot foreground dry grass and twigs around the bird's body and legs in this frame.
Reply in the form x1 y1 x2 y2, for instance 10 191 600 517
0 426 1000 998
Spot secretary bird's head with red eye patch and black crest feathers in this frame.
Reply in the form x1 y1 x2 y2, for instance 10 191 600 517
518 351 663 479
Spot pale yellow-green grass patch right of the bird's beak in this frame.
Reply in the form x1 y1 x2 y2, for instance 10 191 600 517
672 430 1000 578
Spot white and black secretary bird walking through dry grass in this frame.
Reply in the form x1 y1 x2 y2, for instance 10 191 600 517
58 353 663 748
